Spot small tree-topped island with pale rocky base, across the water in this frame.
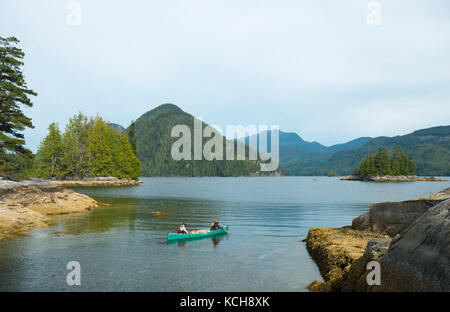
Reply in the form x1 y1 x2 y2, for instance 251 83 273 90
340 146 447 182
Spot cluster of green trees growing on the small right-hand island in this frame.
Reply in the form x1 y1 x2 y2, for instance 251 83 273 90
353 146 416 177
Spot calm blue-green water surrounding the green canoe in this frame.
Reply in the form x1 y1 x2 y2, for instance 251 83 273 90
0 177 449 291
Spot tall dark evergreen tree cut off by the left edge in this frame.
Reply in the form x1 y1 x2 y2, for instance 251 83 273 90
0 37 37 169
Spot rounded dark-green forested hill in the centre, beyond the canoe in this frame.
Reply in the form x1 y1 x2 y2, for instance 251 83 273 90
127 104 260 176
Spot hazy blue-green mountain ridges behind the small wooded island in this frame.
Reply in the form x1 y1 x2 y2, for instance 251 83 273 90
243 126 450 176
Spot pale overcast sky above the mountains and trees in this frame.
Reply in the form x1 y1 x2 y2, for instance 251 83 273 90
0 0 450 150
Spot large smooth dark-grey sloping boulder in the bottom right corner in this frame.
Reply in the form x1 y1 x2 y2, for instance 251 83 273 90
342 199 450 292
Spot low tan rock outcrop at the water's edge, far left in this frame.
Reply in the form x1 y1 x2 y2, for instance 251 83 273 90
0 179 100 238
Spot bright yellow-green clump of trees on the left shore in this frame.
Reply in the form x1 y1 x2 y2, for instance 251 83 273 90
32 113 141 178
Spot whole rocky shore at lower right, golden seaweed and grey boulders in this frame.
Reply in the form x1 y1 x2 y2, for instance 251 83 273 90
304 188 450 291
